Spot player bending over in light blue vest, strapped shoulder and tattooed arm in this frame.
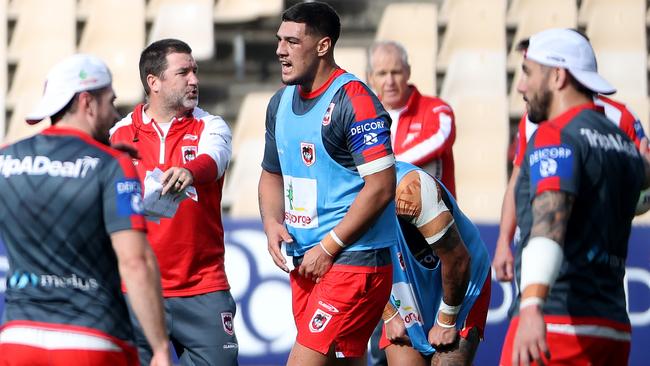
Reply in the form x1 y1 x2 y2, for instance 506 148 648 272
380 162 490 365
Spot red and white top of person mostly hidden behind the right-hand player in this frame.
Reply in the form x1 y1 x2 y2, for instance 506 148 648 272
513 95 645 166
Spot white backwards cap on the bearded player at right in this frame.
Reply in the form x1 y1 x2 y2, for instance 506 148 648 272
526 28 616 94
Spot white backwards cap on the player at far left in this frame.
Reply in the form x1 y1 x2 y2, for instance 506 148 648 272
25 54 112 125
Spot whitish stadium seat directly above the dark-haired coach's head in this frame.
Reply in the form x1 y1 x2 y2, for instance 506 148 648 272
149 0 215 61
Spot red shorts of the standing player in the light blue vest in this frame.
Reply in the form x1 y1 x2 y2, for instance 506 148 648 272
290 265 393 358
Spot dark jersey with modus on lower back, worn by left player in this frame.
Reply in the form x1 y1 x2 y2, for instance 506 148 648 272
0 126 145 340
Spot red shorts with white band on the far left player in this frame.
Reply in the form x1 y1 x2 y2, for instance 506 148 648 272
0 321 140 366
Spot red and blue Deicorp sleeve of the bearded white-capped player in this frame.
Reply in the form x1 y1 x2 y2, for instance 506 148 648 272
524 125 583 200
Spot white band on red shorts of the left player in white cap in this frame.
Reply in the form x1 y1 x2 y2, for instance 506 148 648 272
0 326 122 352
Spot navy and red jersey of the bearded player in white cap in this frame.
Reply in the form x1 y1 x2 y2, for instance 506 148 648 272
515 103 645 326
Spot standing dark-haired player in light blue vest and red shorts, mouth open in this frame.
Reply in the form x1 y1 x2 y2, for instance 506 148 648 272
259 2 397 366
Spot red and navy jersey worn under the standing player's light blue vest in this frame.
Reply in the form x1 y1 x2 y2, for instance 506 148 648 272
262 69 393 177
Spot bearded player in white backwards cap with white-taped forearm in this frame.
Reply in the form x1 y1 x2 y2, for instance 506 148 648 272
500 29 650 365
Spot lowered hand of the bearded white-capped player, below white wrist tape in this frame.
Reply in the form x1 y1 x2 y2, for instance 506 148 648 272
512 305 551 366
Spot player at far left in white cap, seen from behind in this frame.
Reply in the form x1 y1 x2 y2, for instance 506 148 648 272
0 55 171 366
